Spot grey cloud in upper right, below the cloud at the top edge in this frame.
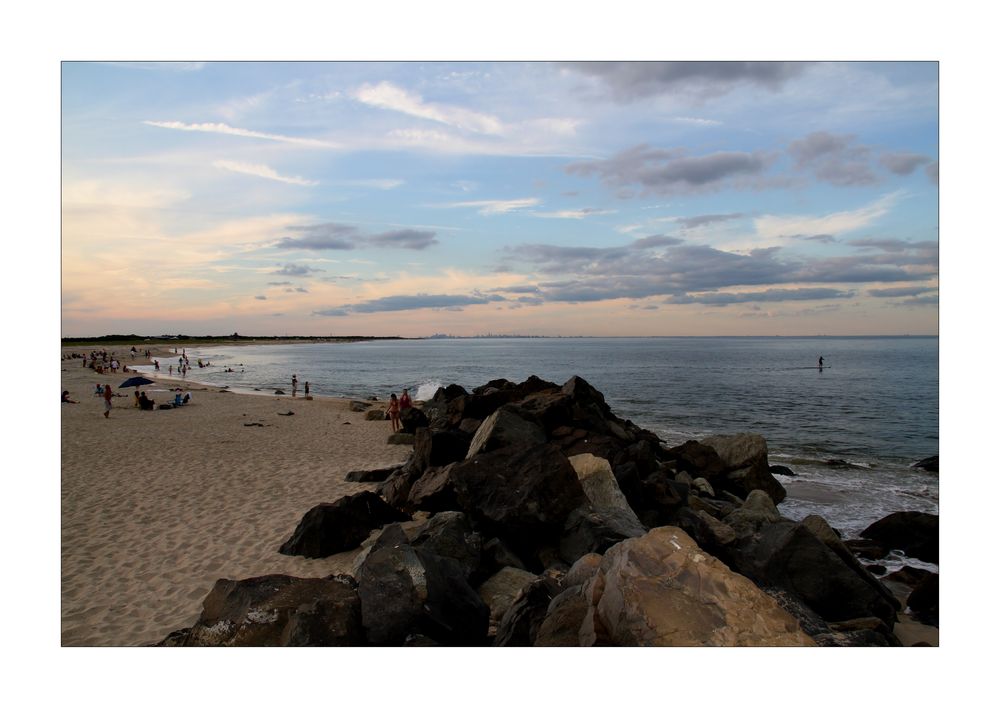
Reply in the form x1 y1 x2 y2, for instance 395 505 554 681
565 145 774 196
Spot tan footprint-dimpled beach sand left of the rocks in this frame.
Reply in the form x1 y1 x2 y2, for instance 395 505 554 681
61 349 411 646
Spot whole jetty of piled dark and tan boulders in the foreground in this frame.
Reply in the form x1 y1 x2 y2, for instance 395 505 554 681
160 376 937 646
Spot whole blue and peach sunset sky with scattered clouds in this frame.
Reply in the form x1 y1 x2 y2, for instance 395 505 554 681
61 61 939 336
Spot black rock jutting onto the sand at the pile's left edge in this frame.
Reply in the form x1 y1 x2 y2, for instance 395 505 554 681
278 491 409 558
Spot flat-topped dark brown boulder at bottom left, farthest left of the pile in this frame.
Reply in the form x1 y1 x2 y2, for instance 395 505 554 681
161 575 365 647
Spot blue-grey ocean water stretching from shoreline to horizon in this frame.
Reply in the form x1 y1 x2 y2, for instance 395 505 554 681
140 337 939 569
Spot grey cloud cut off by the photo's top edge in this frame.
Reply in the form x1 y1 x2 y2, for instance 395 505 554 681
565 61 808 102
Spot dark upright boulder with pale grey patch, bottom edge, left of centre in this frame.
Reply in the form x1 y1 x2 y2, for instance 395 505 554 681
357 525 489 646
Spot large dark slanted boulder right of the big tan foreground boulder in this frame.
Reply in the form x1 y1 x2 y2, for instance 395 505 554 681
727 512 897 626
